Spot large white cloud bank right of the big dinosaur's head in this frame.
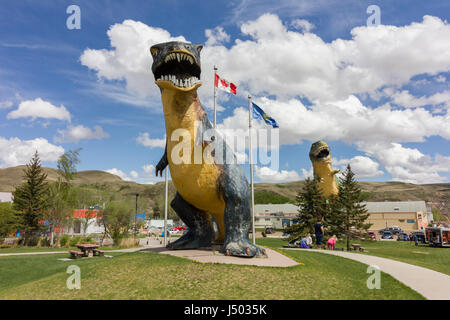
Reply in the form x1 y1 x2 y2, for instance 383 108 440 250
201 14 450 101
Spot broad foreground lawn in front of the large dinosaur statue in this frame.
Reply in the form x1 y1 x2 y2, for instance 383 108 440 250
0 239 423 300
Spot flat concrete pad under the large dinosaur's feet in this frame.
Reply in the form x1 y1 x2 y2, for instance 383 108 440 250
142 247 299 267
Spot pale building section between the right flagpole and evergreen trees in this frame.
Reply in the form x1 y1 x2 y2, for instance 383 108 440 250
255 203 298 229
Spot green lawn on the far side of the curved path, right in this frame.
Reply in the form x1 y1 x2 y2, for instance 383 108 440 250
261 238 450 275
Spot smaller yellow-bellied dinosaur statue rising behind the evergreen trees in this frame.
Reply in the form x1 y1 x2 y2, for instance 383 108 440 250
309 141 339 198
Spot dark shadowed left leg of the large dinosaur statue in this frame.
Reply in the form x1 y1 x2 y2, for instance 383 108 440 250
167 193 214 250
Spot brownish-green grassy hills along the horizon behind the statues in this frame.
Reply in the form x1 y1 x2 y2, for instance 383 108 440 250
0 166 450 215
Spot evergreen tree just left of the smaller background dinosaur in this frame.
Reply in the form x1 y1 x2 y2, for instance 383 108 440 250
286 178 328 241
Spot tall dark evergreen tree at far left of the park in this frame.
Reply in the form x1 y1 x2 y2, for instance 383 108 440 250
13 151 49 244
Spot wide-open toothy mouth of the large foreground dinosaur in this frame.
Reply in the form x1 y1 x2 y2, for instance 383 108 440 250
154 51 201 88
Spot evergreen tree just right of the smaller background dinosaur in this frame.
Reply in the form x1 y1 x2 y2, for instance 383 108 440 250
329 164 371 250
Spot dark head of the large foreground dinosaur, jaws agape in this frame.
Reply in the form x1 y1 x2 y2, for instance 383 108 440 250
150 41 203 91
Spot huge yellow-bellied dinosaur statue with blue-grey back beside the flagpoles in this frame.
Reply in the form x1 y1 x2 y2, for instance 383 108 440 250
150 42 265 257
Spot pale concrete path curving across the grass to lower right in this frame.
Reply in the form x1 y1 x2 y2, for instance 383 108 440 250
284 248 450 300
